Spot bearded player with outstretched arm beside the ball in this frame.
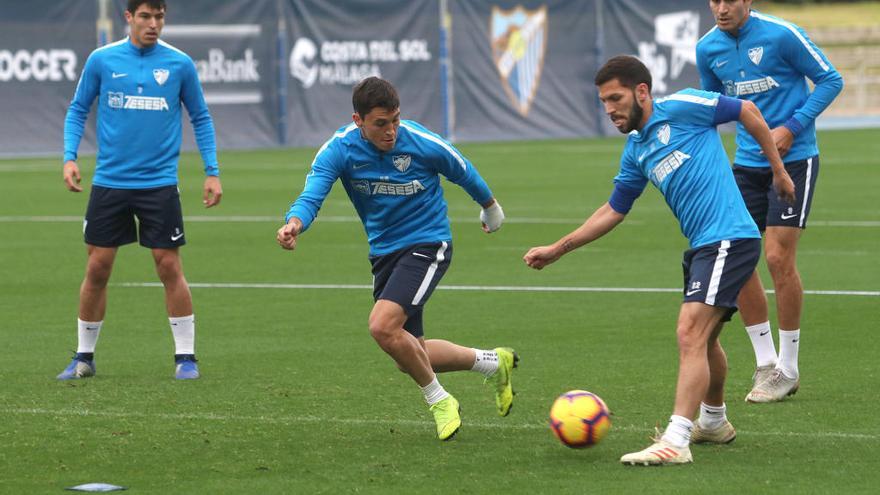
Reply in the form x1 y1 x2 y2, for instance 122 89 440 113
523 56 794 465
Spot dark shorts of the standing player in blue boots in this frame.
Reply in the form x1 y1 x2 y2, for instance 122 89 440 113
83 185 186 249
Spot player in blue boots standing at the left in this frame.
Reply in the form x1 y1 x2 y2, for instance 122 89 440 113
58 0 223 380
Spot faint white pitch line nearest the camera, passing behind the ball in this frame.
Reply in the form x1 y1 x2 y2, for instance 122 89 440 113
0 408 880 441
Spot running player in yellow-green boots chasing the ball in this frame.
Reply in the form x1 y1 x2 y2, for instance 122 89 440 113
277 77 519 440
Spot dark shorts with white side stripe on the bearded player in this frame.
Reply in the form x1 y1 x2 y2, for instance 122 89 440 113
681 239 761 321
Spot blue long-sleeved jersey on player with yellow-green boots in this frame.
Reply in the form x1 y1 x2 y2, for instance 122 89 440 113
284 120 492 255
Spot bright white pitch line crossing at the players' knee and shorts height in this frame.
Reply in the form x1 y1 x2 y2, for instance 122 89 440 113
113 282 880 297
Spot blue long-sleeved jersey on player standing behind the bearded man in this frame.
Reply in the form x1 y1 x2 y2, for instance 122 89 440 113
697 11 843 167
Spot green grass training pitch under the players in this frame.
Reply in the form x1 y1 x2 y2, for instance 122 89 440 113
0 131 880 494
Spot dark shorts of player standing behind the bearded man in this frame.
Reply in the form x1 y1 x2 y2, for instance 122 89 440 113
733 155 819 232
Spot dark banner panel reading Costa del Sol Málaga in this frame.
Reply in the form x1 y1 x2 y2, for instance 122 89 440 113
285 0 443 146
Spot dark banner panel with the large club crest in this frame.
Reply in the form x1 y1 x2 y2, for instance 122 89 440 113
449 0 598 141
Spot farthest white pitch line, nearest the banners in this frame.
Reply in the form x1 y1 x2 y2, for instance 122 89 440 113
0 215 880 228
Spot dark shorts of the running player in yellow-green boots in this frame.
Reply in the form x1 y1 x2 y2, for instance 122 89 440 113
370 241 452 338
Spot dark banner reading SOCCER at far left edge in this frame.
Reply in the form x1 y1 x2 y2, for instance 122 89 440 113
0 0 97 157
